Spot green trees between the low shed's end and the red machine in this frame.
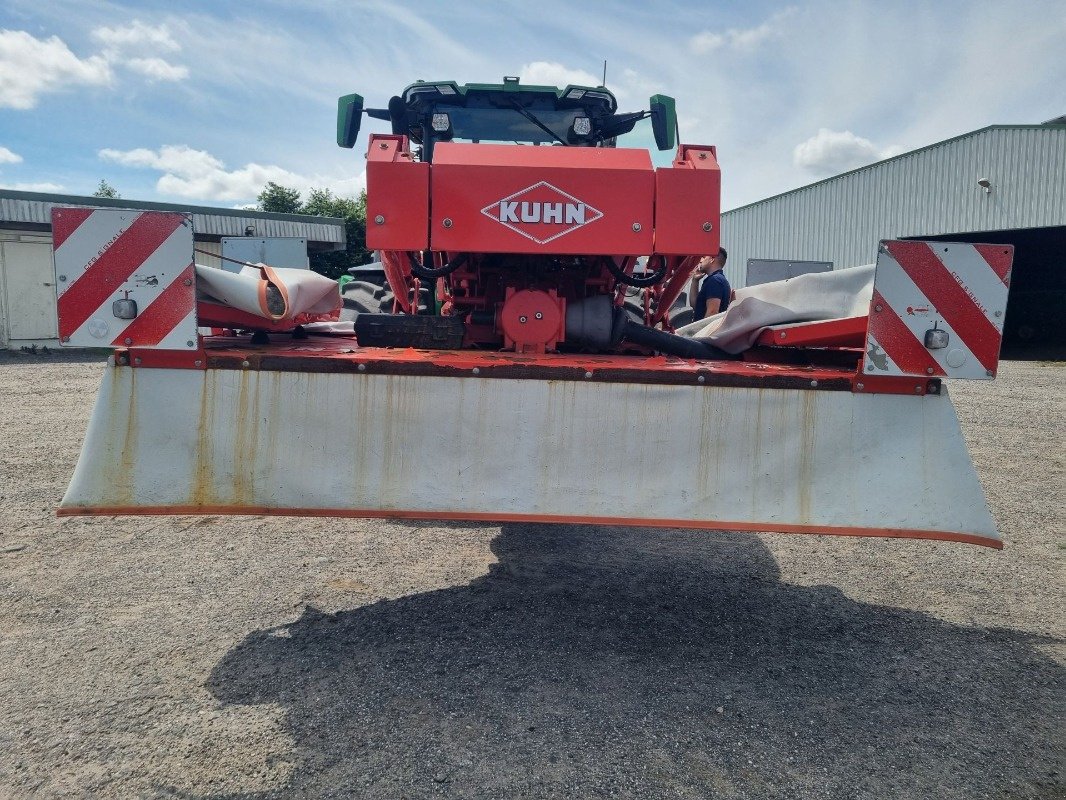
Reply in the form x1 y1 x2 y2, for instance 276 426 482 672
257 181 370 279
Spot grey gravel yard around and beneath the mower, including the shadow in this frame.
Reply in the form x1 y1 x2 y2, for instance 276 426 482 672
0 354 1066 799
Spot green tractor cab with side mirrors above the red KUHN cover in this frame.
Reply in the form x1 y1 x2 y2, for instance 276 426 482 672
337 77 676 161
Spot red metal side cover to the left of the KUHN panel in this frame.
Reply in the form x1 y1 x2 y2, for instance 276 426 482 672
367 133 430 250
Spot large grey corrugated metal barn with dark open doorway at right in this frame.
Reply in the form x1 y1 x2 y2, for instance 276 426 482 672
722 118 1066 338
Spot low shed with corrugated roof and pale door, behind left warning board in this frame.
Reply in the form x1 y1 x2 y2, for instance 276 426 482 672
0 190 345 348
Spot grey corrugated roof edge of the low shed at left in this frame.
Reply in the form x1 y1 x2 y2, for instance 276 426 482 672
0 189 345 250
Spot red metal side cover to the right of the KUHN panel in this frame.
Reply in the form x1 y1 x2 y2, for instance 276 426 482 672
655 144 722 256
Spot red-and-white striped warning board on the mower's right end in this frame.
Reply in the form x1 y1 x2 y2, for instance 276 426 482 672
865 240 1014 379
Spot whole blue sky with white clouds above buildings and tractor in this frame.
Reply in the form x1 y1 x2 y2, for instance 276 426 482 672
0 0 1066 208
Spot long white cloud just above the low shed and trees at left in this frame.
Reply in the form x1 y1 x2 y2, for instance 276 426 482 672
97 145 356 202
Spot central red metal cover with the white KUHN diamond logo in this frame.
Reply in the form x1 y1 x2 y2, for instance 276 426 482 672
431 142 655 255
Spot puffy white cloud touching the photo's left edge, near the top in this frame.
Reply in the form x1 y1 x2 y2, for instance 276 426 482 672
0 31 113 110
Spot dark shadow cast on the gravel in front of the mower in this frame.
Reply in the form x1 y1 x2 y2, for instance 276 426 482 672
203 525 1066 798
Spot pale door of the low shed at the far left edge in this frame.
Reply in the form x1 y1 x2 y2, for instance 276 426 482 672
0 237 59 339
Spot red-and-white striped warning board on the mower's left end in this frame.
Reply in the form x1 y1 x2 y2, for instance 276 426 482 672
52 208 197 350
